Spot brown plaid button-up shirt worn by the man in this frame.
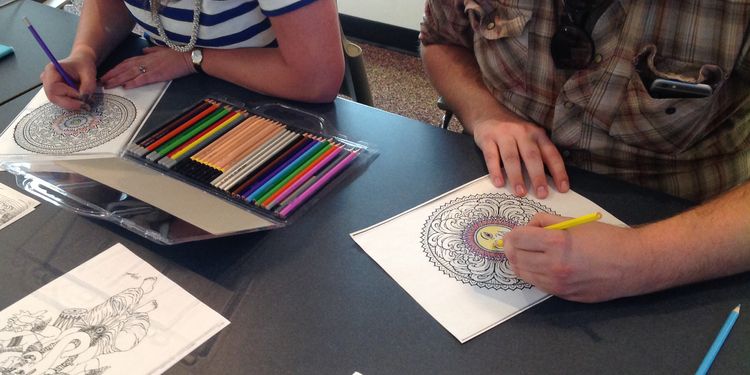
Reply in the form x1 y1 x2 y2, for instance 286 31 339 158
420 0 750 200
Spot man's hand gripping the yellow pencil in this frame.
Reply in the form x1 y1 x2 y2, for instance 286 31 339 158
504 214 649 302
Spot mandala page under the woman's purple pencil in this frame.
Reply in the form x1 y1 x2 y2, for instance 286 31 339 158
0 82 169 161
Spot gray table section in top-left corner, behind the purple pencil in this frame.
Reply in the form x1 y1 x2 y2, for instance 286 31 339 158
0 0 78 106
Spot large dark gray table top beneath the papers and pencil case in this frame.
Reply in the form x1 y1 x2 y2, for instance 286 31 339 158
0 15 750 375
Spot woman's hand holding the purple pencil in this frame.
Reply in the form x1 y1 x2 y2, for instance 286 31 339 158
39 48 96 111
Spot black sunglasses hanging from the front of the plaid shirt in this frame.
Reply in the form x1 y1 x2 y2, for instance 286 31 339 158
550 0 612 70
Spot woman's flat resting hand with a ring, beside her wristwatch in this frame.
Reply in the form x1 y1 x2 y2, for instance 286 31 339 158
101 46 195 89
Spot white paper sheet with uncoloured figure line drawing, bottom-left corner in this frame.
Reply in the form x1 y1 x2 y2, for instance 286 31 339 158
0 244 229 375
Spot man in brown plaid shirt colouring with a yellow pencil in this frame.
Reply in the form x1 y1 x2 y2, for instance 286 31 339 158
420 0 750 301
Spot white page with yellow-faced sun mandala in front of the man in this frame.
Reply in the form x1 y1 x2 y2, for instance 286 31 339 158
351 176 625 343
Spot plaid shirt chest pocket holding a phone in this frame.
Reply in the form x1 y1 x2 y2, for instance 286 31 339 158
609 45 725 154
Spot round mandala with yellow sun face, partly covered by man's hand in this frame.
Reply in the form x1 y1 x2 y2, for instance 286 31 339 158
422 194 554 290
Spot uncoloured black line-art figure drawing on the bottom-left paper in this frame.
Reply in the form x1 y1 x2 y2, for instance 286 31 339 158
0 277 158 375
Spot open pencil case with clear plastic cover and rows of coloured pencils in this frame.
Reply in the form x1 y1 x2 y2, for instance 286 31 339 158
7 95 377 244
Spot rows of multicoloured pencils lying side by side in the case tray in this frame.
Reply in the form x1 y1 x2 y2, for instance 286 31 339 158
128 99 362 218
